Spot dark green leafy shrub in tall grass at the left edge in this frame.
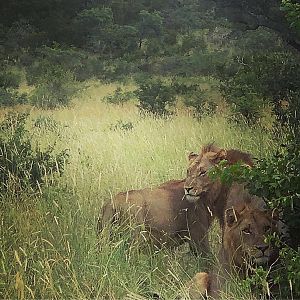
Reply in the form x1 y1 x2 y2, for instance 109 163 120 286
0 113 68 193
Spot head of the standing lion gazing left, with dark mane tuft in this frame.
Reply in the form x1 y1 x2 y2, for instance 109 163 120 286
184 144 253 202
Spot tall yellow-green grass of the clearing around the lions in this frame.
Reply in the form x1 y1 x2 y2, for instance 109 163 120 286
0 84 282 299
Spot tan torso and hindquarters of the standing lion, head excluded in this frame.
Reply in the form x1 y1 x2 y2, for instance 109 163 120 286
98 179 211 254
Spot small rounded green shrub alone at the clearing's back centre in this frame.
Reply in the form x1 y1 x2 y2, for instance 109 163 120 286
135 79 176 116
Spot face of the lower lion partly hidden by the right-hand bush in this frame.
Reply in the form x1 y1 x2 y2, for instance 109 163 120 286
223 198 278 269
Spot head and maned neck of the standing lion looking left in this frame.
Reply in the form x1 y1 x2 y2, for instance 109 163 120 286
184 144 254 227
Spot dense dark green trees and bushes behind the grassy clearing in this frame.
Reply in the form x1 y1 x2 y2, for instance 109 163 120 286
0 0 300 122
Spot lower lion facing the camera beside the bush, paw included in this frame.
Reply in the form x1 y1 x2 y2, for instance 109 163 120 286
187 184 279 299
